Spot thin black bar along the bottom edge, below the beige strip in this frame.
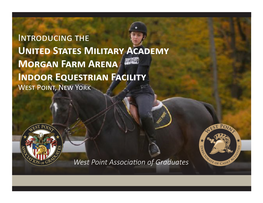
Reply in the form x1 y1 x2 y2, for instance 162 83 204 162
12 186 251 191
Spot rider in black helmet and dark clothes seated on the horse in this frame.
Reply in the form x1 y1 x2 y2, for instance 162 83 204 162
106 22 160 157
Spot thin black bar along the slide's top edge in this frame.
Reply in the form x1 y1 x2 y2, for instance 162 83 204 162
12 12 251 17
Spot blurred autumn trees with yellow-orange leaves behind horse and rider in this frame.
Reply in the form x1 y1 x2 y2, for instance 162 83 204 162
12 17 251 139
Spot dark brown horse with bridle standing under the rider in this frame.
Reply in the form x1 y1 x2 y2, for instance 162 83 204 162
51 85 221 174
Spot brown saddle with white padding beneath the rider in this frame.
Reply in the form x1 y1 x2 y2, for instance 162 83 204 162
123 94 163 125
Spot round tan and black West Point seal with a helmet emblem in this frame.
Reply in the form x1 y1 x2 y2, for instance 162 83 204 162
199 123 241 166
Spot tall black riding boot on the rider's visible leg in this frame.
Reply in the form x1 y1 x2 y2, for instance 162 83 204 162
141 117 161 158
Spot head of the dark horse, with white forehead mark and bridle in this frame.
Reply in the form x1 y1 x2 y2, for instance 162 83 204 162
50 85 79 142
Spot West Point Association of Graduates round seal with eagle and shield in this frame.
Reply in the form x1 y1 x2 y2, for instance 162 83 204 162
20 123 63 166
